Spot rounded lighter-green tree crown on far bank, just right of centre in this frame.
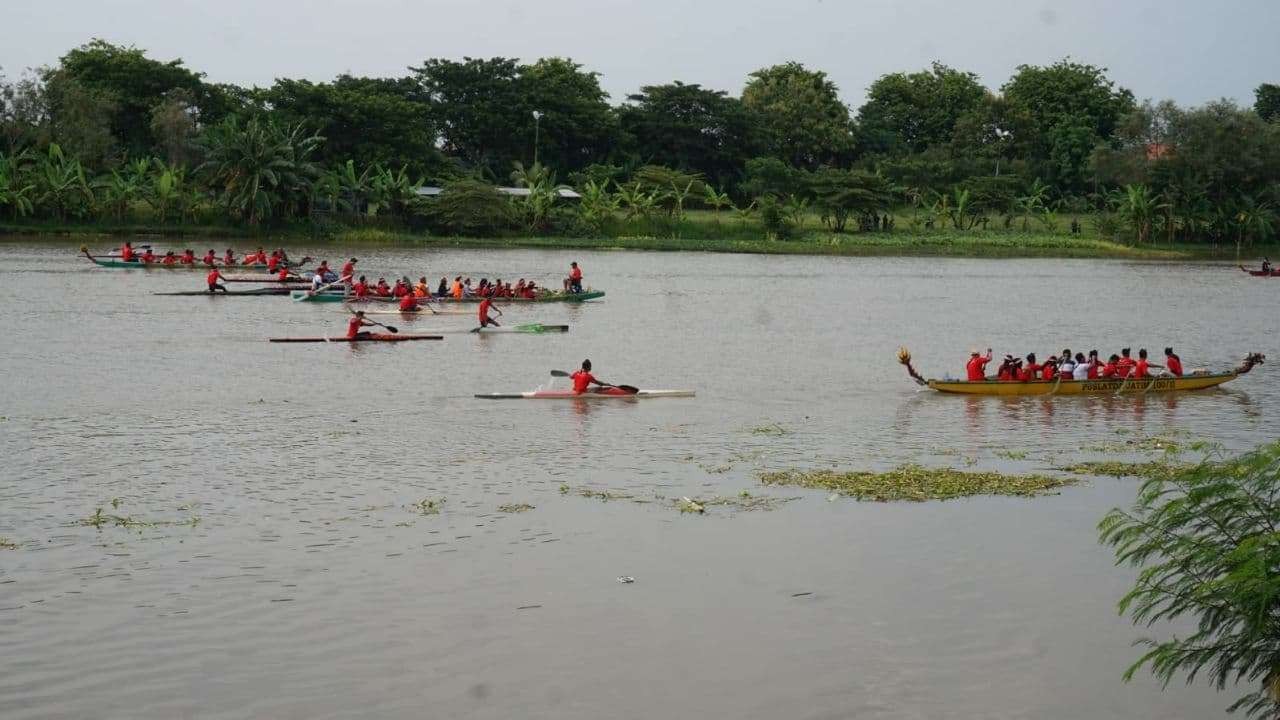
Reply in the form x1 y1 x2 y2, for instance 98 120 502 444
742 63 852 168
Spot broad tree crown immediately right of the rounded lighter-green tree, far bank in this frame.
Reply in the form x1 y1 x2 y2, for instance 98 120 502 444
858 63 987 152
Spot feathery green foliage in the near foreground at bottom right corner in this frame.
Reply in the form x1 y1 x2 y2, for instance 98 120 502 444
1098 443 1280 717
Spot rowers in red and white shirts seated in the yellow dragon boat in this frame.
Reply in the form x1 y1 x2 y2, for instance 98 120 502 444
965 347 1183 383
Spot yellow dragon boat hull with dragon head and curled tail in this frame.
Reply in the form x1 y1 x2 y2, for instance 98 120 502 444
897 347 1266 396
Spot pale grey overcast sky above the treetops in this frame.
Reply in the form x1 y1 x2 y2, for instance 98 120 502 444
0 0 1280 109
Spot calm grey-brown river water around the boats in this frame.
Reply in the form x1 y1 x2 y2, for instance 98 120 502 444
0 242 1280 720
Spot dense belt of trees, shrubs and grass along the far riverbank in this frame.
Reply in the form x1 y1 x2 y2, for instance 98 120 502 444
0 40 1280 256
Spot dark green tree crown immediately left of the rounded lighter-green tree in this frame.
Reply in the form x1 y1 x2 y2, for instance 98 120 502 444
618 82 760 187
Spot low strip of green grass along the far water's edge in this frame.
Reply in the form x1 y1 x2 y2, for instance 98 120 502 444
0 211 1280 260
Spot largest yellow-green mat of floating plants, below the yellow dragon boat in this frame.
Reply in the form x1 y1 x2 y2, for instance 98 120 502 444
760 465 1078 502
